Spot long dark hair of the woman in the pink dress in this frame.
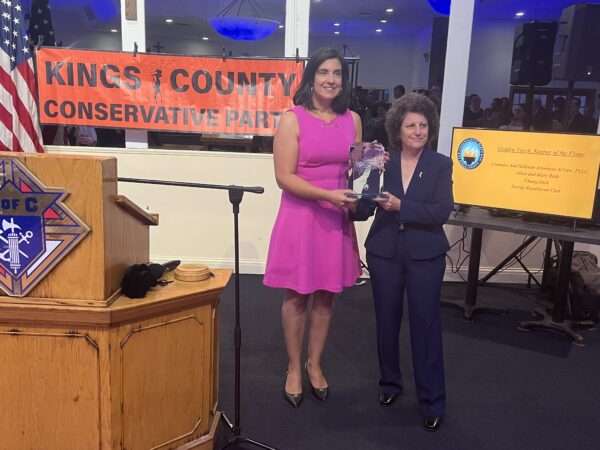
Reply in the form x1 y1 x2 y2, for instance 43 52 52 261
294 47 350 114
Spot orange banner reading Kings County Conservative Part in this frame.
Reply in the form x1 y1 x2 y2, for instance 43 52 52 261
36 47 304 135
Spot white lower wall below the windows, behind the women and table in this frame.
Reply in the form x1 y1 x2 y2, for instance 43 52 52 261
48 147 590 282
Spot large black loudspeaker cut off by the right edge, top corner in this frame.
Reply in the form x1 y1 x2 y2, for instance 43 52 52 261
552 3 600 81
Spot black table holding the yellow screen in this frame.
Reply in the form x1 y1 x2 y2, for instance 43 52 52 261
442 207 600 345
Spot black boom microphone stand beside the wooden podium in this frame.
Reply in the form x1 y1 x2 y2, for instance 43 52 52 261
117 177 277 450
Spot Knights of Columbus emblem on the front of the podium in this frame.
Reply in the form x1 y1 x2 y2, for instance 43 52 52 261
0 158 90 297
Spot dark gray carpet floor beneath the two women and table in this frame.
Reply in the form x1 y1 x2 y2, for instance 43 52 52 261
217 275 600 450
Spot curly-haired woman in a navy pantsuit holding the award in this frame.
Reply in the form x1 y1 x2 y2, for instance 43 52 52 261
353 94 454 431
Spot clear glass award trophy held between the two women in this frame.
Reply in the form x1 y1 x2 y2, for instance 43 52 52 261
348 142 384 198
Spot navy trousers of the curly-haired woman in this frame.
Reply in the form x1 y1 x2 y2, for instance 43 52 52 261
367 231 446 417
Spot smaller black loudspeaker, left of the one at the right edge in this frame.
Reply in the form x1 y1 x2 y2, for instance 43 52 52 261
510 22 558 86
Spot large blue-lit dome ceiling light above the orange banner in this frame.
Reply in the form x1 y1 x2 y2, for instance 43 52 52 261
208 0 281 41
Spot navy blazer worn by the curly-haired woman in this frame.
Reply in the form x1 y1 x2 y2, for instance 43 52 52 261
350 149 454 260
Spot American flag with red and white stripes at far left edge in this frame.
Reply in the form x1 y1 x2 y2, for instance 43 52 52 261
0 0 44 153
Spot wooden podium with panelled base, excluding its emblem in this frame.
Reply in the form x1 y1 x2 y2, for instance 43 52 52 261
0 155 231 450
